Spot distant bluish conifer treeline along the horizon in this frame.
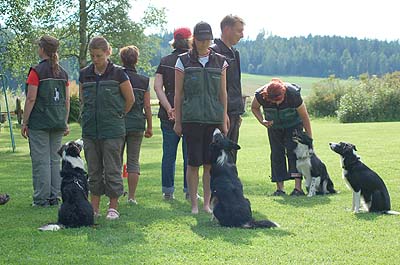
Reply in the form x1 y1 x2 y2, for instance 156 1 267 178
152 32 400 78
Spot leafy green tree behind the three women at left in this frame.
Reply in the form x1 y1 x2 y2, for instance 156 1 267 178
0 0 166 81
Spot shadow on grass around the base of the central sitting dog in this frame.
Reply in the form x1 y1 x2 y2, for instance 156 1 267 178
192 209 292 245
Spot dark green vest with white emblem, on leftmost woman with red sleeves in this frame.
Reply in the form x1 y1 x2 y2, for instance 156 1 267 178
28 60 69 130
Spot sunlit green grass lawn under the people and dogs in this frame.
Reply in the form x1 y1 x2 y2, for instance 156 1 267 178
0 115 400 264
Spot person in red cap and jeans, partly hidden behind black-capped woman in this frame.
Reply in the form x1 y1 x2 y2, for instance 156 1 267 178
154 28 192 200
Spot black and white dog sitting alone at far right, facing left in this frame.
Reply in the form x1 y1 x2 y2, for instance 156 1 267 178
329 142 399 214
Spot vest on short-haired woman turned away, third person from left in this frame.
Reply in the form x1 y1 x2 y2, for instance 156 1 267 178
125 68 149 132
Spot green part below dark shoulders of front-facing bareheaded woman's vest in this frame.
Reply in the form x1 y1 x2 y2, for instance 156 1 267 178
82 80 125 139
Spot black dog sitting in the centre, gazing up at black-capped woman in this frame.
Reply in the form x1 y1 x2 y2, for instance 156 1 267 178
210 129 278 228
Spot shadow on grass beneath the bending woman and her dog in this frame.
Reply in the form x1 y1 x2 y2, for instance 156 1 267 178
272 194 335 207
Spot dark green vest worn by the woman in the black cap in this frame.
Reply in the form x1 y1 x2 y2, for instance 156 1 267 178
179 51 225 124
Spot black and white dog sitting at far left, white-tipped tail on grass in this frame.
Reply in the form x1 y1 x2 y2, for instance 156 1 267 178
39 139 94 231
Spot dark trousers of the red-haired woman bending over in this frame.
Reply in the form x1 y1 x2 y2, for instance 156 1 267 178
268 126 302 182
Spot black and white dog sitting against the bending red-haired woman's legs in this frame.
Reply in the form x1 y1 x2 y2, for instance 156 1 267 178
292 130 336 197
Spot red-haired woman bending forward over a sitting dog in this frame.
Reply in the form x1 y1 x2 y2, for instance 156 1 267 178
251 78 312 196
